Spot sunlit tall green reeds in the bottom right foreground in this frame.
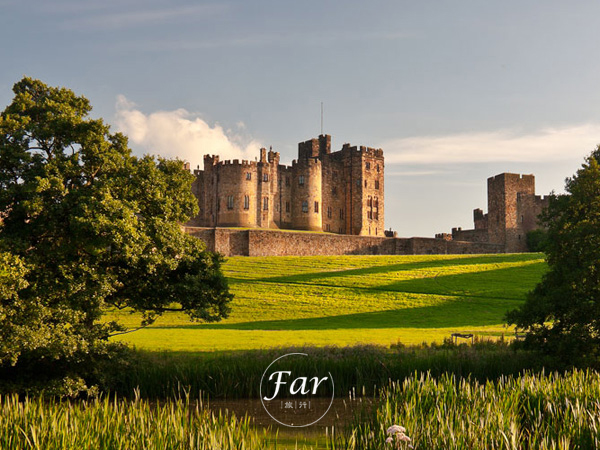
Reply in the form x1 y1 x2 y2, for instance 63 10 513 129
346 370 600 449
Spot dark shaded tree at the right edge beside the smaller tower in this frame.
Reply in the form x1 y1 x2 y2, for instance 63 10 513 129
507 146 600 362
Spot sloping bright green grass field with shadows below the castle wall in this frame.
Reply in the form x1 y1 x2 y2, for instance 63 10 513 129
108 254 546 352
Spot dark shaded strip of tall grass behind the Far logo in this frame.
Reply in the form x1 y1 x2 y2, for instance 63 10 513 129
105 342 552 399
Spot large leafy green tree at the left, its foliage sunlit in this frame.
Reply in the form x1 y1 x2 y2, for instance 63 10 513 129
0 78 232 394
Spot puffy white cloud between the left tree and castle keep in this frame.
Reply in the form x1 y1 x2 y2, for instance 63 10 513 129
115 95 261 168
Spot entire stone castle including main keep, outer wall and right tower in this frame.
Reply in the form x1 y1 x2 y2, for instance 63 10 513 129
185 135 548 256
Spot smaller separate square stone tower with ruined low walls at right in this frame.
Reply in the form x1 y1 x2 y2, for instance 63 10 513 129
436 173 548 253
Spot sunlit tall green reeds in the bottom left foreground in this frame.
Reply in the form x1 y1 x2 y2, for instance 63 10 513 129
0 395 270 450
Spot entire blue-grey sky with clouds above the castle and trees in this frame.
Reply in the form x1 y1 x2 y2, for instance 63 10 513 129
0 0 600 237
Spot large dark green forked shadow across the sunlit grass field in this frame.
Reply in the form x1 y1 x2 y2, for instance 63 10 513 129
146 262 544 330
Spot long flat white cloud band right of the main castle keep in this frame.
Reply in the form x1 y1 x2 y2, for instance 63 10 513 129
381 124 600 164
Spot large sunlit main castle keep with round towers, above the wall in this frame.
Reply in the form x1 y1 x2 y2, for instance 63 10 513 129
189 135 384 236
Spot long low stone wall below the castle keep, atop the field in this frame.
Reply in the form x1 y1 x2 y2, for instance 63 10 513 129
185 227 503 256
